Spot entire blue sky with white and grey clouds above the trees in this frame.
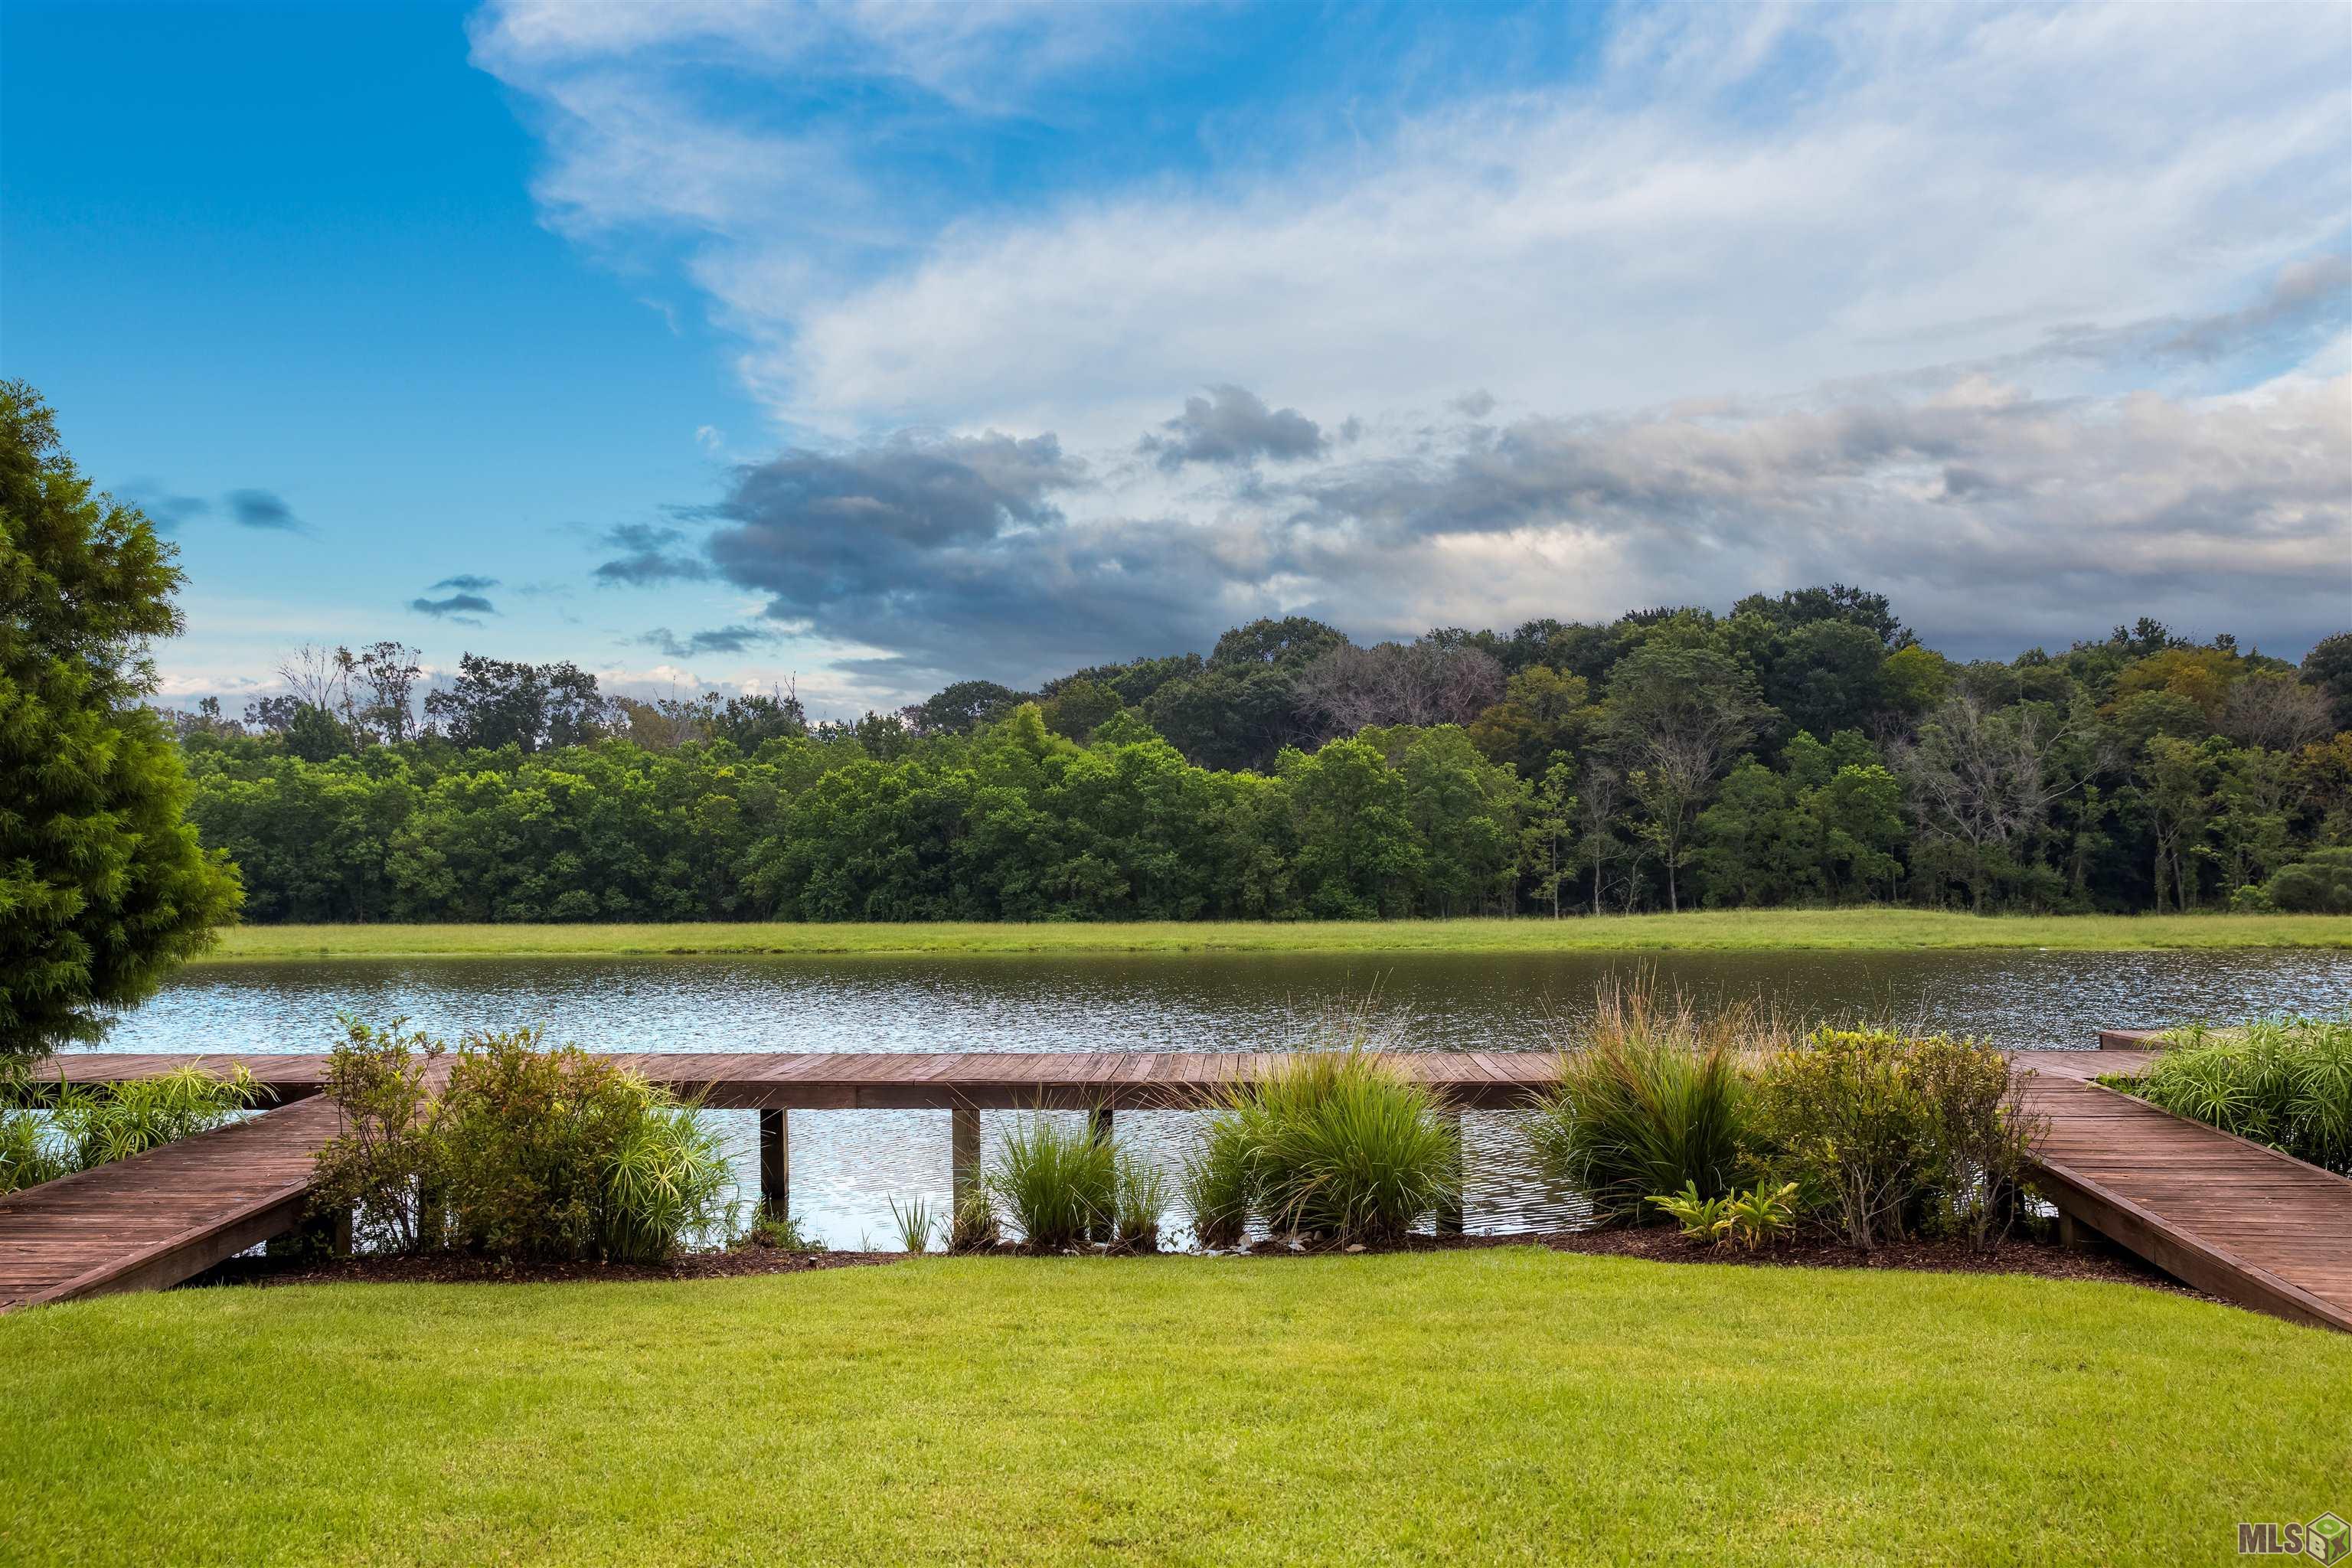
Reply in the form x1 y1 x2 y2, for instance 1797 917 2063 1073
0 0 2352 712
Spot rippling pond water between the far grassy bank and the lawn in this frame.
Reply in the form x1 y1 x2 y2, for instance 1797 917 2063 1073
106 949 2352 1246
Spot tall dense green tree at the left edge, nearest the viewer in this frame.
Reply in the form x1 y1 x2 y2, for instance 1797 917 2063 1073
0 381 237 1060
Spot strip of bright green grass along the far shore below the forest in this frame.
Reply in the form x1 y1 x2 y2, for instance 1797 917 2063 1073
207 910 2352 964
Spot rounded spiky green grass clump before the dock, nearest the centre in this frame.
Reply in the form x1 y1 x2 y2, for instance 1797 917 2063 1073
1195 1046 1461 1241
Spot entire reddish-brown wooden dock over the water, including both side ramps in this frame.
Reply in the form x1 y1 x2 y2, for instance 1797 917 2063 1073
0 1037 2352 1331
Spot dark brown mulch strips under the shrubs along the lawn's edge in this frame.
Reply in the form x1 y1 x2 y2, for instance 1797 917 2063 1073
191 1227 2220 1300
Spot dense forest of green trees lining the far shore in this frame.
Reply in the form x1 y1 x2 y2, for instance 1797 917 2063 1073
169 586 2352 922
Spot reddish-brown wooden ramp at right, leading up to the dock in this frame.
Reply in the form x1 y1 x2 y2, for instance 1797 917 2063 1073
2011 1048 2352 1331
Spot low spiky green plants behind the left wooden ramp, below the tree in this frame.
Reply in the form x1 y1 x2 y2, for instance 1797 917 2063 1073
0 1065 263 1192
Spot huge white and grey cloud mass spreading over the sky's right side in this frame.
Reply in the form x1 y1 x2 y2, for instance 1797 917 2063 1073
475 0 2352 687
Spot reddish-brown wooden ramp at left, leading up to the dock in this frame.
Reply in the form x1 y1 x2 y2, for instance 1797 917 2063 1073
0 1100 336 1312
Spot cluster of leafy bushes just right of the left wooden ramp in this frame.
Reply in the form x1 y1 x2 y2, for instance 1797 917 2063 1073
313 1018 733 1263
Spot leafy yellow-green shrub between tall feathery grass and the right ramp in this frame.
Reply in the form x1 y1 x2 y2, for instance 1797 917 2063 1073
1750 1030 2037 1246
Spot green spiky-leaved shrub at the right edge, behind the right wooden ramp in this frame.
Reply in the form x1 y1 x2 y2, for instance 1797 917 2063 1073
2128 1018 2352 1175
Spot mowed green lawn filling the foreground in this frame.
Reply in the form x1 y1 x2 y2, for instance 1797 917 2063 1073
0 1248 2352 1566
